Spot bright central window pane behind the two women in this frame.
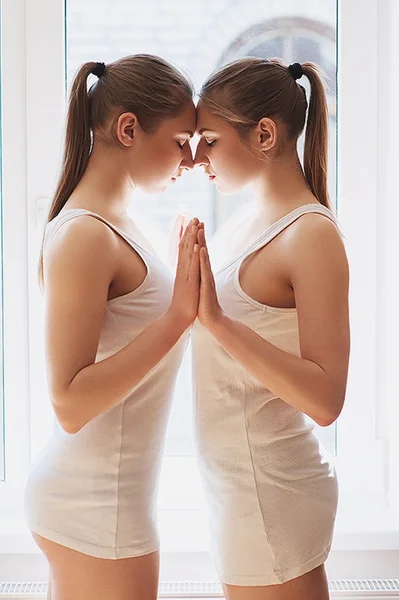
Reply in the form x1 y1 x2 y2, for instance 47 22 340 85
30 0 336 549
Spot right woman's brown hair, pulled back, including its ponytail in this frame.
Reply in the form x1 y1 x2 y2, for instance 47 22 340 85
200 57 331 208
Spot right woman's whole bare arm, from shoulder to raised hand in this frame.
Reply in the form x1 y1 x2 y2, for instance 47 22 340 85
200 217 350 426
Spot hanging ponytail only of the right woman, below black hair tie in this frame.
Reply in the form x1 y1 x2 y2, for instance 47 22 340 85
301 63 331 208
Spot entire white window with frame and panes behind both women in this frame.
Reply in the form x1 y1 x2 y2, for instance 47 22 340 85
0 0 399 568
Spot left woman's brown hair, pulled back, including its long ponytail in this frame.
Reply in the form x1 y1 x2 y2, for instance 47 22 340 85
39 54 193 289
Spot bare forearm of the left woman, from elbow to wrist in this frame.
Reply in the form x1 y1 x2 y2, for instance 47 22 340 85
54 312 184 433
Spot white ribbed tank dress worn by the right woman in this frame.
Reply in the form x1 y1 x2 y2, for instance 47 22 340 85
191 204 338 586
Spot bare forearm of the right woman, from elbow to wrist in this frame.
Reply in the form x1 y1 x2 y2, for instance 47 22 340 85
209 316 341 425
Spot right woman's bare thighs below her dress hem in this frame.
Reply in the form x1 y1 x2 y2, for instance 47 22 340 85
223 565 330 600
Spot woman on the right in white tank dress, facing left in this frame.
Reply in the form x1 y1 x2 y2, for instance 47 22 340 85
193 58 349 600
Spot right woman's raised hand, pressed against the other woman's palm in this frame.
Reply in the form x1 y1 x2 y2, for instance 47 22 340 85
198 223 224 329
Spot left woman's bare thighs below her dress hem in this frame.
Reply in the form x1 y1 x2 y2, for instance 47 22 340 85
33 534 159 600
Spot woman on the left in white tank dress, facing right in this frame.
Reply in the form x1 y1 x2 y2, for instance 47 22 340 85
26 55 199 600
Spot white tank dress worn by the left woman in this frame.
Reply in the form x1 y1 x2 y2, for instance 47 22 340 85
25 209 187 559
